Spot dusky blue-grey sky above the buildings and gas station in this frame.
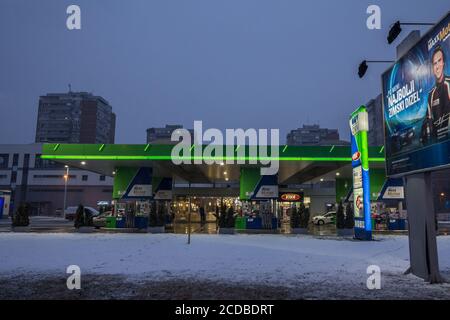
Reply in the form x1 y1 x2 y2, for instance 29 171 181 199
0 0 450 143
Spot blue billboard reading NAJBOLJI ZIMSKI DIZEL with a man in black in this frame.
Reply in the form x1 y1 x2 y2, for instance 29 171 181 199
382 13 450 176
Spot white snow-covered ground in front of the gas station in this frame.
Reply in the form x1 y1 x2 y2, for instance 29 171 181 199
0 233 450 299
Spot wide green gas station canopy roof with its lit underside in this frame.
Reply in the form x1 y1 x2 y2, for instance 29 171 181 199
41 143 385 184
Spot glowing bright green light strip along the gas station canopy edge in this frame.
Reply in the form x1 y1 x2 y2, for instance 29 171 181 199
41 155 385 162
